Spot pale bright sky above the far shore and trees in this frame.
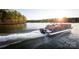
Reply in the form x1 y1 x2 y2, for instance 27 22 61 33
17 9 79 20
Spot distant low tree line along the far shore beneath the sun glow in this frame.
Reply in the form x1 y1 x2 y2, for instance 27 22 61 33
27 17 79 23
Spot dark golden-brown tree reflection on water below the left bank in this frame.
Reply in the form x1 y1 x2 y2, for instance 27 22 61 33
0 24 26 33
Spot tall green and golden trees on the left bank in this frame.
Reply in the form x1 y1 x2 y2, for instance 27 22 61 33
0 9 26 24
